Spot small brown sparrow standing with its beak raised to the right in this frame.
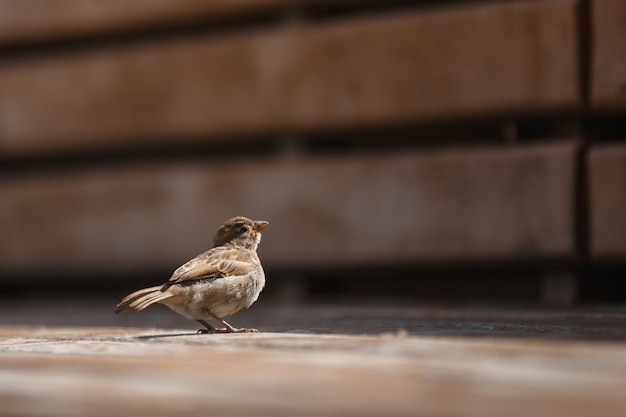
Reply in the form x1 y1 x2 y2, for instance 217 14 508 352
115 216 269 334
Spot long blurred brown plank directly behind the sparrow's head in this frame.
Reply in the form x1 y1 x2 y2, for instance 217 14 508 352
0 143 576 273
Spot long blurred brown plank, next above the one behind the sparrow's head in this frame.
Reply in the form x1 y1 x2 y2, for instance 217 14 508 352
0 0 580 154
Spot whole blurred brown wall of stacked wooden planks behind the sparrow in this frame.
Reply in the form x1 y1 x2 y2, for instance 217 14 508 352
0 0 626 304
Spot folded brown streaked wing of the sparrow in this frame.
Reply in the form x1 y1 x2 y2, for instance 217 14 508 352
166 248 254 286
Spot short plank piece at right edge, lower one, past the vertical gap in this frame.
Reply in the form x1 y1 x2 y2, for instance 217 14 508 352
589 144 626 262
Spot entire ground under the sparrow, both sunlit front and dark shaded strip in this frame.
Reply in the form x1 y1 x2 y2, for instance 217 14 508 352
0 300 626 417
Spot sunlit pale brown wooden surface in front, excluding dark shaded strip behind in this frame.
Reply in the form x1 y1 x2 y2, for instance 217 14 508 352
0 323 626 417
